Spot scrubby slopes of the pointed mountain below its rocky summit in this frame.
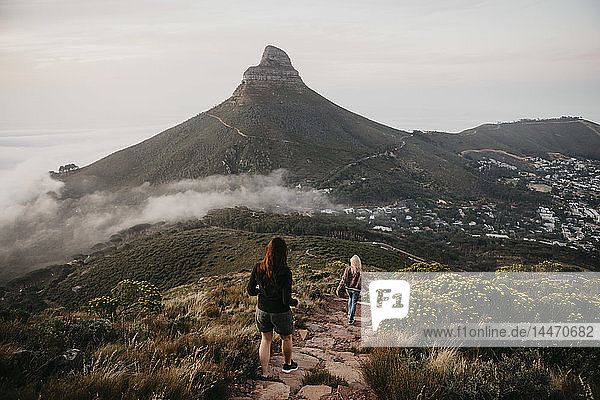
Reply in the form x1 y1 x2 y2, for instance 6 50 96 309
59 86 406 198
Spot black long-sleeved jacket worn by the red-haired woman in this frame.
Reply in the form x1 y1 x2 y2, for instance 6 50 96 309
248 264 298 313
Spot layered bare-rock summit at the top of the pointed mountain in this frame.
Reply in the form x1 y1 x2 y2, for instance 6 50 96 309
242 45 303 85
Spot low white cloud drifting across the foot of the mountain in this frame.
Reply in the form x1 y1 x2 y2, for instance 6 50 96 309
0 168 332 282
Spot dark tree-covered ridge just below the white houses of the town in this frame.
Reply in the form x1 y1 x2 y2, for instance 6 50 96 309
204 207 600 271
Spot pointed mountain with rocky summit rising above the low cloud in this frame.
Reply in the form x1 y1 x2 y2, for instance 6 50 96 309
58 45 596 203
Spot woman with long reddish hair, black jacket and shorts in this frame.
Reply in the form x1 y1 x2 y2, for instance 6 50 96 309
248 237 298 377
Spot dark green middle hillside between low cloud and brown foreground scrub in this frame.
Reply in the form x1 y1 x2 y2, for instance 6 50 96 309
0 207 600 311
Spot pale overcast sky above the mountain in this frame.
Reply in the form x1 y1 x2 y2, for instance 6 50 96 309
0 0 600 173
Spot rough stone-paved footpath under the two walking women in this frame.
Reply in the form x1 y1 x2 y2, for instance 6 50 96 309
236 297 374 400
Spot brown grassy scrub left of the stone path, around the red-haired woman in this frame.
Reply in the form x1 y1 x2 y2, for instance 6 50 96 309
0 256 345 400
